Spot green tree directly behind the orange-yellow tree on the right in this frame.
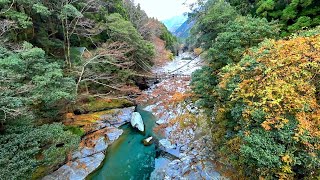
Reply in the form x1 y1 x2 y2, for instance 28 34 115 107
192 16 279 107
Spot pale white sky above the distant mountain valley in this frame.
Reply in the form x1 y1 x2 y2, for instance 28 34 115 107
134 0 196 21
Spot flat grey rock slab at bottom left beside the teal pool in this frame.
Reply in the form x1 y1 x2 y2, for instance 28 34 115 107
43 152 104 180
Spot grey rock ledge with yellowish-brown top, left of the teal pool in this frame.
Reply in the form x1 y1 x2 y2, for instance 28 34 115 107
43 107 134 180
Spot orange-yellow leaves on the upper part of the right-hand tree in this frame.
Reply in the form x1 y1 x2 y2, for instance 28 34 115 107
218 35 320 143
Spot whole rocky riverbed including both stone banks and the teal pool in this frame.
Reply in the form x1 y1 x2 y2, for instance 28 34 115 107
43 53 222 180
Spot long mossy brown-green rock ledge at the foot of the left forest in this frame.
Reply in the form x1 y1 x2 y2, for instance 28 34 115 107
74 98 134 114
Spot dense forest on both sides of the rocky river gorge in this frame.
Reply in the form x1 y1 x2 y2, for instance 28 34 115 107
0 0 320 179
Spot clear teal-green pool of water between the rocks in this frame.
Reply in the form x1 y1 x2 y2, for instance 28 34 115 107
87 107 156 180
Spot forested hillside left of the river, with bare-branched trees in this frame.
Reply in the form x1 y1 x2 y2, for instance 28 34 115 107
0 0 177 179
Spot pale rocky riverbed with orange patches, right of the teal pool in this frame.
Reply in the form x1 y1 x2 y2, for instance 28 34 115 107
137 53 223 180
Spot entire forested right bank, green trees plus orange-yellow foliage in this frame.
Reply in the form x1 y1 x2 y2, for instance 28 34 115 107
188 0 320 179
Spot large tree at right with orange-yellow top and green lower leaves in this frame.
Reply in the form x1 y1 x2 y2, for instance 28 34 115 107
213 32 320 179
